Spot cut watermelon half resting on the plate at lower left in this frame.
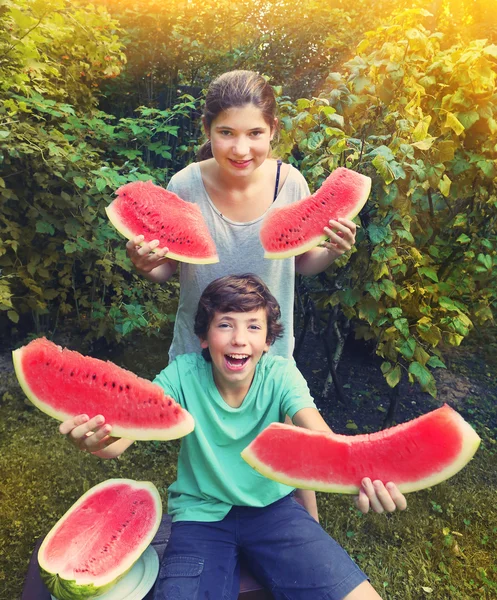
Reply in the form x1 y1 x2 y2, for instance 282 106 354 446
38 479 162 600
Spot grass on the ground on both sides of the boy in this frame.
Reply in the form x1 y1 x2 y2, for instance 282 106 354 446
0 336 497 600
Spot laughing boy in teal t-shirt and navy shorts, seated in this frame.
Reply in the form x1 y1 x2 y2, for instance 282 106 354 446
60 274 405 600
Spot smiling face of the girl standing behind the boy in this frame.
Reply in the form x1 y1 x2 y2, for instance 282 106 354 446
204 104 277 177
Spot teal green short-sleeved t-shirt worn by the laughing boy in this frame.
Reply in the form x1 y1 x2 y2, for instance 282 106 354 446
154 354 315 521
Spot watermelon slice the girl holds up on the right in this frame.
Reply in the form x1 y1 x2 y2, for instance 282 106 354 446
260 167 371 258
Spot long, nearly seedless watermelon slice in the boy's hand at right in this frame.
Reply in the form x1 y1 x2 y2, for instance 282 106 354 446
242 404 480 494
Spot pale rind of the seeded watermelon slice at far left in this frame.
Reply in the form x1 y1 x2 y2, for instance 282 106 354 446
12 344 195 441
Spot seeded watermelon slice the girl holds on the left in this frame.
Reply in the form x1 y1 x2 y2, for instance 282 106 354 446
105 181 219 264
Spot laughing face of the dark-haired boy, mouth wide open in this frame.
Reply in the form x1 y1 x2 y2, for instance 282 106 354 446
201 308 269 391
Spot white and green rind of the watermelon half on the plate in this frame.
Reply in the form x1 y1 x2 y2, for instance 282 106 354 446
38 479 162 600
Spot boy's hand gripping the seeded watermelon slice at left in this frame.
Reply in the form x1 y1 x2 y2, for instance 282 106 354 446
59 415 118 452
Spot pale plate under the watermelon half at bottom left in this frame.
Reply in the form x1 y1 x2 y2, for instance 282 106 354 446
51 546 159 600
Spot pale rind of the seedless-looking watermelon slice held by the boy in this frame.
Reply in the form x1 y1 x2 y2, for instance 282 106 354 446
241 405 481 494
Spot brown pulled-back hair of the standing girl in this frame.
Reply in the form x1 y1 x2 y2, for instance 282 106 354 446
197 71 276 161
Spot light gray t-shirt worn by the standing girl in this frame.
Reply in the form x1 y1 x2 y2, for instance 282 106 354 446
167 163 310 361
